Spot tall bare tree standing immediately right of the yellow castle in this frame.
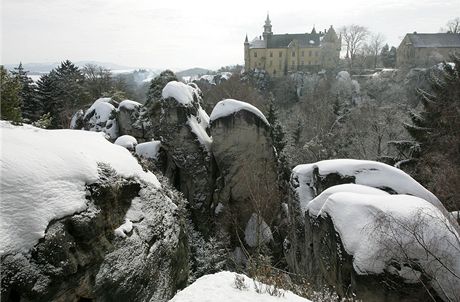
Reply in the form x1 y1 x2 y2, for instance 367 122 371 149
340 24 369 69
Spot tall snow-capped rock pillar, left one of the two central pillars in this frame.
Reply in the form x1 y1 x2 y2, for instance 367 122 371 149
148 81 213 232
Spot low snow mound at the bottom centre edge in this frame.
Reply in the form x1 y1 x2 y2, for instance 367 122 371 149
169 271 310 302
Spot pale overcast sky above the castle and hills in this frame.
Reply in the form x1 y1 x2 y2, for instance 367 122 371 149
0 0 460 70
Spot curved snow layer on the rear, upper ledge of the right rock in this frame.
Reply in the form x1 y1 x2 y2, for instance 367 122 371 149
293 159 443 209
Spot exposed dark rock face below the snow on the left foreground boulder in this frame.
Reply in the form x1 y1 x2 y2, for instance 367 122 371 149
2 167 188 301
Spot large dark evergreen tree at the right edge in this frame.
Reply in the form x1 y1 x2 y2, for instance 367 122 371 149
405 56 460 210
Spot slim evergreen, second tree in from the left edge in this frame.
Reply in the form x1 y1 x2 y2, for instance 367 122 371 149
12 63 42 122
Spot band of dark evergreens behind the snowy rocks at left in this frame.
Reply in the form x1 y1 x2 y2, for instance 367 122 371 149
0 60 148 129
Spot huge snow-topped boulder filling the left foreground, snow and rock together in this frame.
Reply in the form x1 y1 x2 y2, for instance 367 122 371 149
0 122 188 301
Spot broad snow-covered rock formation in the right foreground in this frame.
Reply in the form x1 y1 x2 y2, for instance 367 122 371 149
285 159 460 301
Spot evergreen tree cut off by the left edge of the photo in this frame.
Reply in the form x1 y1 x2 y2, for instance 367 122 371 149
0 65 22 123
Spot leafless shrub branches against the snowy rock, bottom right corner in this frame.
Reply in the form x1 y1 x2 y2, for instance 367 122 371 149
372 208 460 302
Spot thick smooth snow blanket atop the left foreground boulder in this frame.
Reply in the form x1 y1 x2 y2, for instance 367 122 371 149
0 121 160 254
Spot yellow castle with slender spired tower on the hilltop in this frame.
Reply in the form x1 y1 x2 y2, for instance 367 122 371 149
244 14 342 77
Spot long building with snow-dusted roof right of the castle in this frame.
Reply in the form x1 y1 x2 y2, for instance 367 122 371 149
396 32 460 67
